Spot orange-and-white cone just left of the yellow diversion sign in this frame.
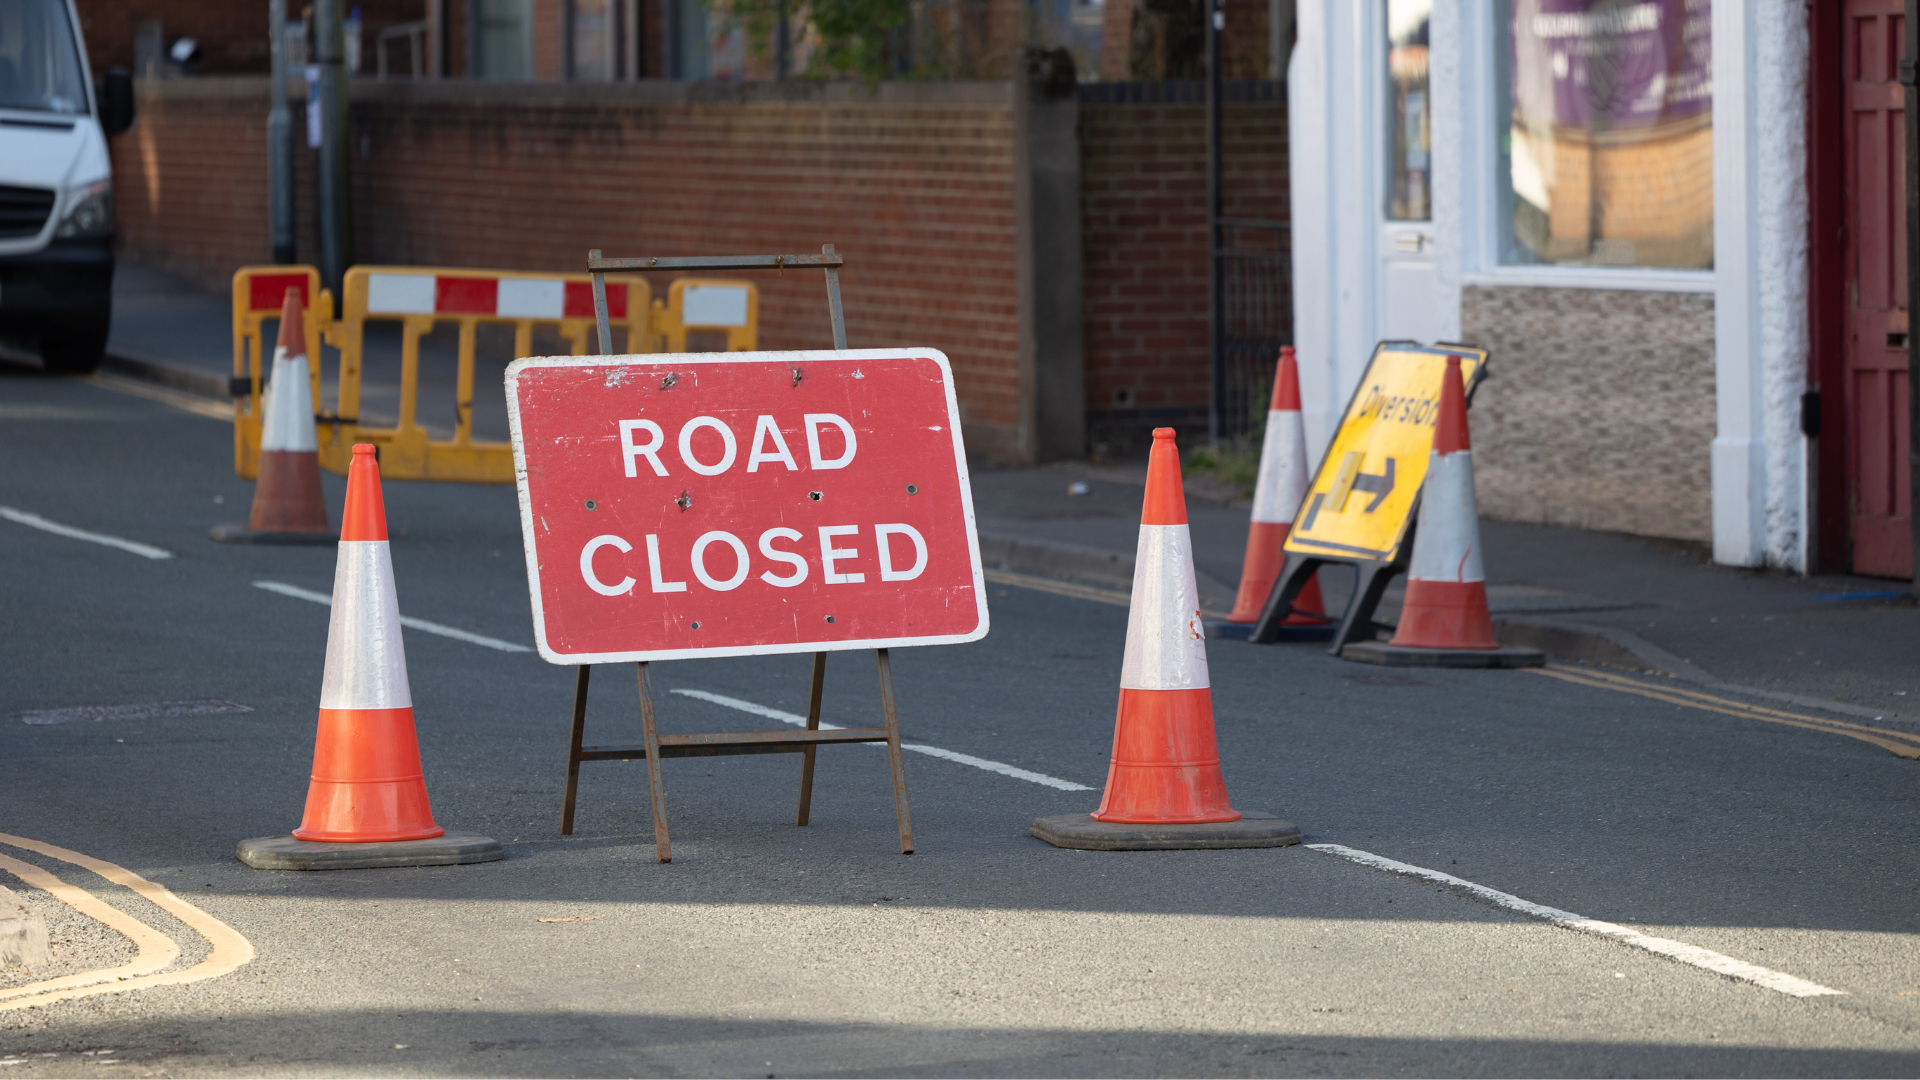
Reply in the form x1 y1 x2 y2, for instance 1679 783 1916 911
1219 346 1331 640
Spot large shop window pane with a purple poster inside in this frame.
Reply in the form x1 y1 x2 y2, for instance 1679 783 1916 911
1496 0 1713 269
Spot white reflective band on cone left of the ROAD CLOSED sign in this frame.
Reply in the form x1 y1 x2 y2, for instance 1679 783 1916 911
321 540 413 709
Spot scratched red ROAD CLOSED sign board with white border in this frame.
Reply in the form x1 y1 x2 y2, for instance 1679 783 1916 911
507 350 987 665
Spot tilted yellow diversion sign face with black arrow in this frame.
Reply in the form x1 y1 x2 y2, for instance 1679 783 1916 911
1284 342 1486 561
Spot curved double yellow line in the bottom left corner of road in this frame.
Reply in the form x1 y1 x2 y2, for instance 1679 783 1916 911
0 832 253 1013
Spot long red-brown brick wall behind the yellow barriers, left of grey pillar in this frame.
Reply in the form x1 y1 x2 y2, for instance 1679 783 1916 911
113 79 1020 449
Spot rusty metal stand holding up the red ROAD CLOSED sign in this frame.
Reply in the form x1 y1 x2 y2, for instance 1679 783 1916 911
561 244 914 863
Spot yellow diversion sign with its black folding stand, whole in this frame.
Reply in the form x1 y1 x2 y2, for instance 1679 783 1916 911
1248 342 1488 655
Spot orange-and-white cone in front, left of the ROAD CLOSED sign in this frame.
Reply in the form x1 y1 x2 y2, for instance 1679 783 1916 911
240 444 499 869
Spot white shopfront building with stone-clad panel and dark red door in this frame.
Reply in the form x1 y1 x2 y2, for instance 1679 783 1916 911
1290 0 1912 577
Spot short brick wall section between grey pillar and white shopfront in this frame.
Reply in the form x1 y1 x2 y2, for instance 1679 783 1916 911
1081 83 1290 450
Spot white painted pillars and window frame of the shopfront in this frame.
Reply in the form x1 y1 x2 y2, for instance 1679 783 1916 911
1288 0 1811 573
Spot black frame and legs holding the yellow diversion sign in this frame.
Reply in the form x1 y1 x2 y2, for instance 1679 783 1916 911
1248 340 1492 655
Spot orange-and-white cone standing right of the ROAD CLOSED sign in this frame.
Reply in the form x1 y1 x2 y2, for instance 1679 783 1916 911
1029 427 1300 849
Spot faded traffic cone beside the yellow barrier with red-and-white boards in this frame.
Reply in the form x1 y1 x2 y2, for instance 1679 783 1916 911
211 288 336 544
